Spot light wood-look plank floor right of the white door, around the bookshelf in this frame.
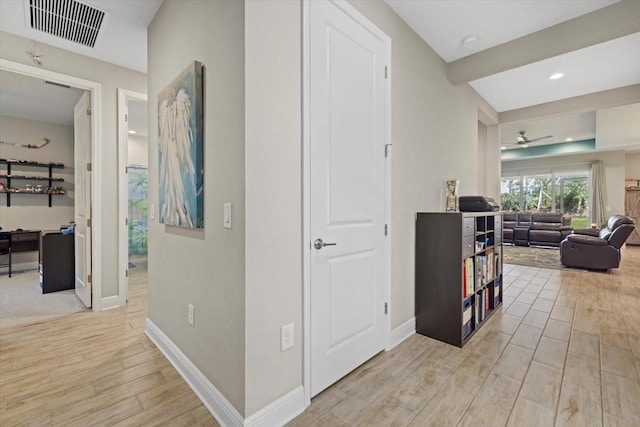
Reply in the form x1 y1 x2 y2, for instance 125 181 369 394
288 247 640 427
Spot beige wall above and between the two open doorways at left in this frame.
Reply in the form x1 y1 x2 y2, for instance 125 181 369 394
0 32 147 298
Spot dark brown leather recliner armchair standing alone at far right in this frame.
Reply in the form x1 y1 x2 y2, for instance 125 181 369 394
560 215 635 270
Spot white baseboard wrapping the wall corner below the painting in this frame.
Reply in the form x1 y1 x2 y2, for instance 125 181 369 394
145 318 305 427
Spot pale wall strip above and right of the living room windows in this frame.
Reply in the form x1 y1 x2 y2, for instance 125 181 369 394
502 151 626 215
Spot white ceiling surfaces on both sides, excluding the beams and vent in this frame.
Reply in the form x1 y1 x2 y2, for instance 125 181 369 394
0 0 640 156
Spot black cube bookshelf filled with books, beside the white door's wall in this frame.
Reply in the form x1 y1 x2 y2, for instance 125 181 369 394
415 212 503 347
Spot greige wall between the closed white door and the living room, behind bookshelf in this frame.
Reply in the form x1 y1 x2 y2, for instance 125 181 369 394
351 1 499 329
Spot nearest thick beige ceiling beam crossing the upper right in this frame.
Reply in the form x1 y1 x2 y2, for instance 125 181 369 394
447 0 640 85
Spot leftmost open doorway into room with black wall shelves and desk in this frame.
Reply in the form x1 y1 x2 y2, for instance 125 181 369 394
0 68 91 327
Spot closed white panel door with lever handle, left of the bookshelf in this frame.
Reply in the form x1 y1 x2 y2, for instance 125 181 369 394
309 1 390 395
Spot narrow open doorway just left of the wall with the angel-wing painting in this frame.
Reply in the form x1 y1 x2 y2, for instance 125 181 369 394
118 89 149 304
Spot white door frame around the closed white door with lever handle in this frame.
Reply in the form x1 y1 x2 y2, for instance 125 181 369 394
302 0 393 406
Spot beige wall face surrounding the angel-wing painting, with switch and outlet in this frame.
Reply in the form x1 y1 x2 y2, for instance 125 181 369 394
148 0 246 414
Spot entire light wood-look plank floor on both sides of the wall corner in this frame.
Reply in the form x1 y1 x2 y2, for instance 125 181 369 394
0 247 640 427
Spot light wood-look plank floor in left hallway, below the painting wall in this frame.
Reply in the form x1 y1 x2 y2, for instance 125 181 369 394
0 269 218 427
